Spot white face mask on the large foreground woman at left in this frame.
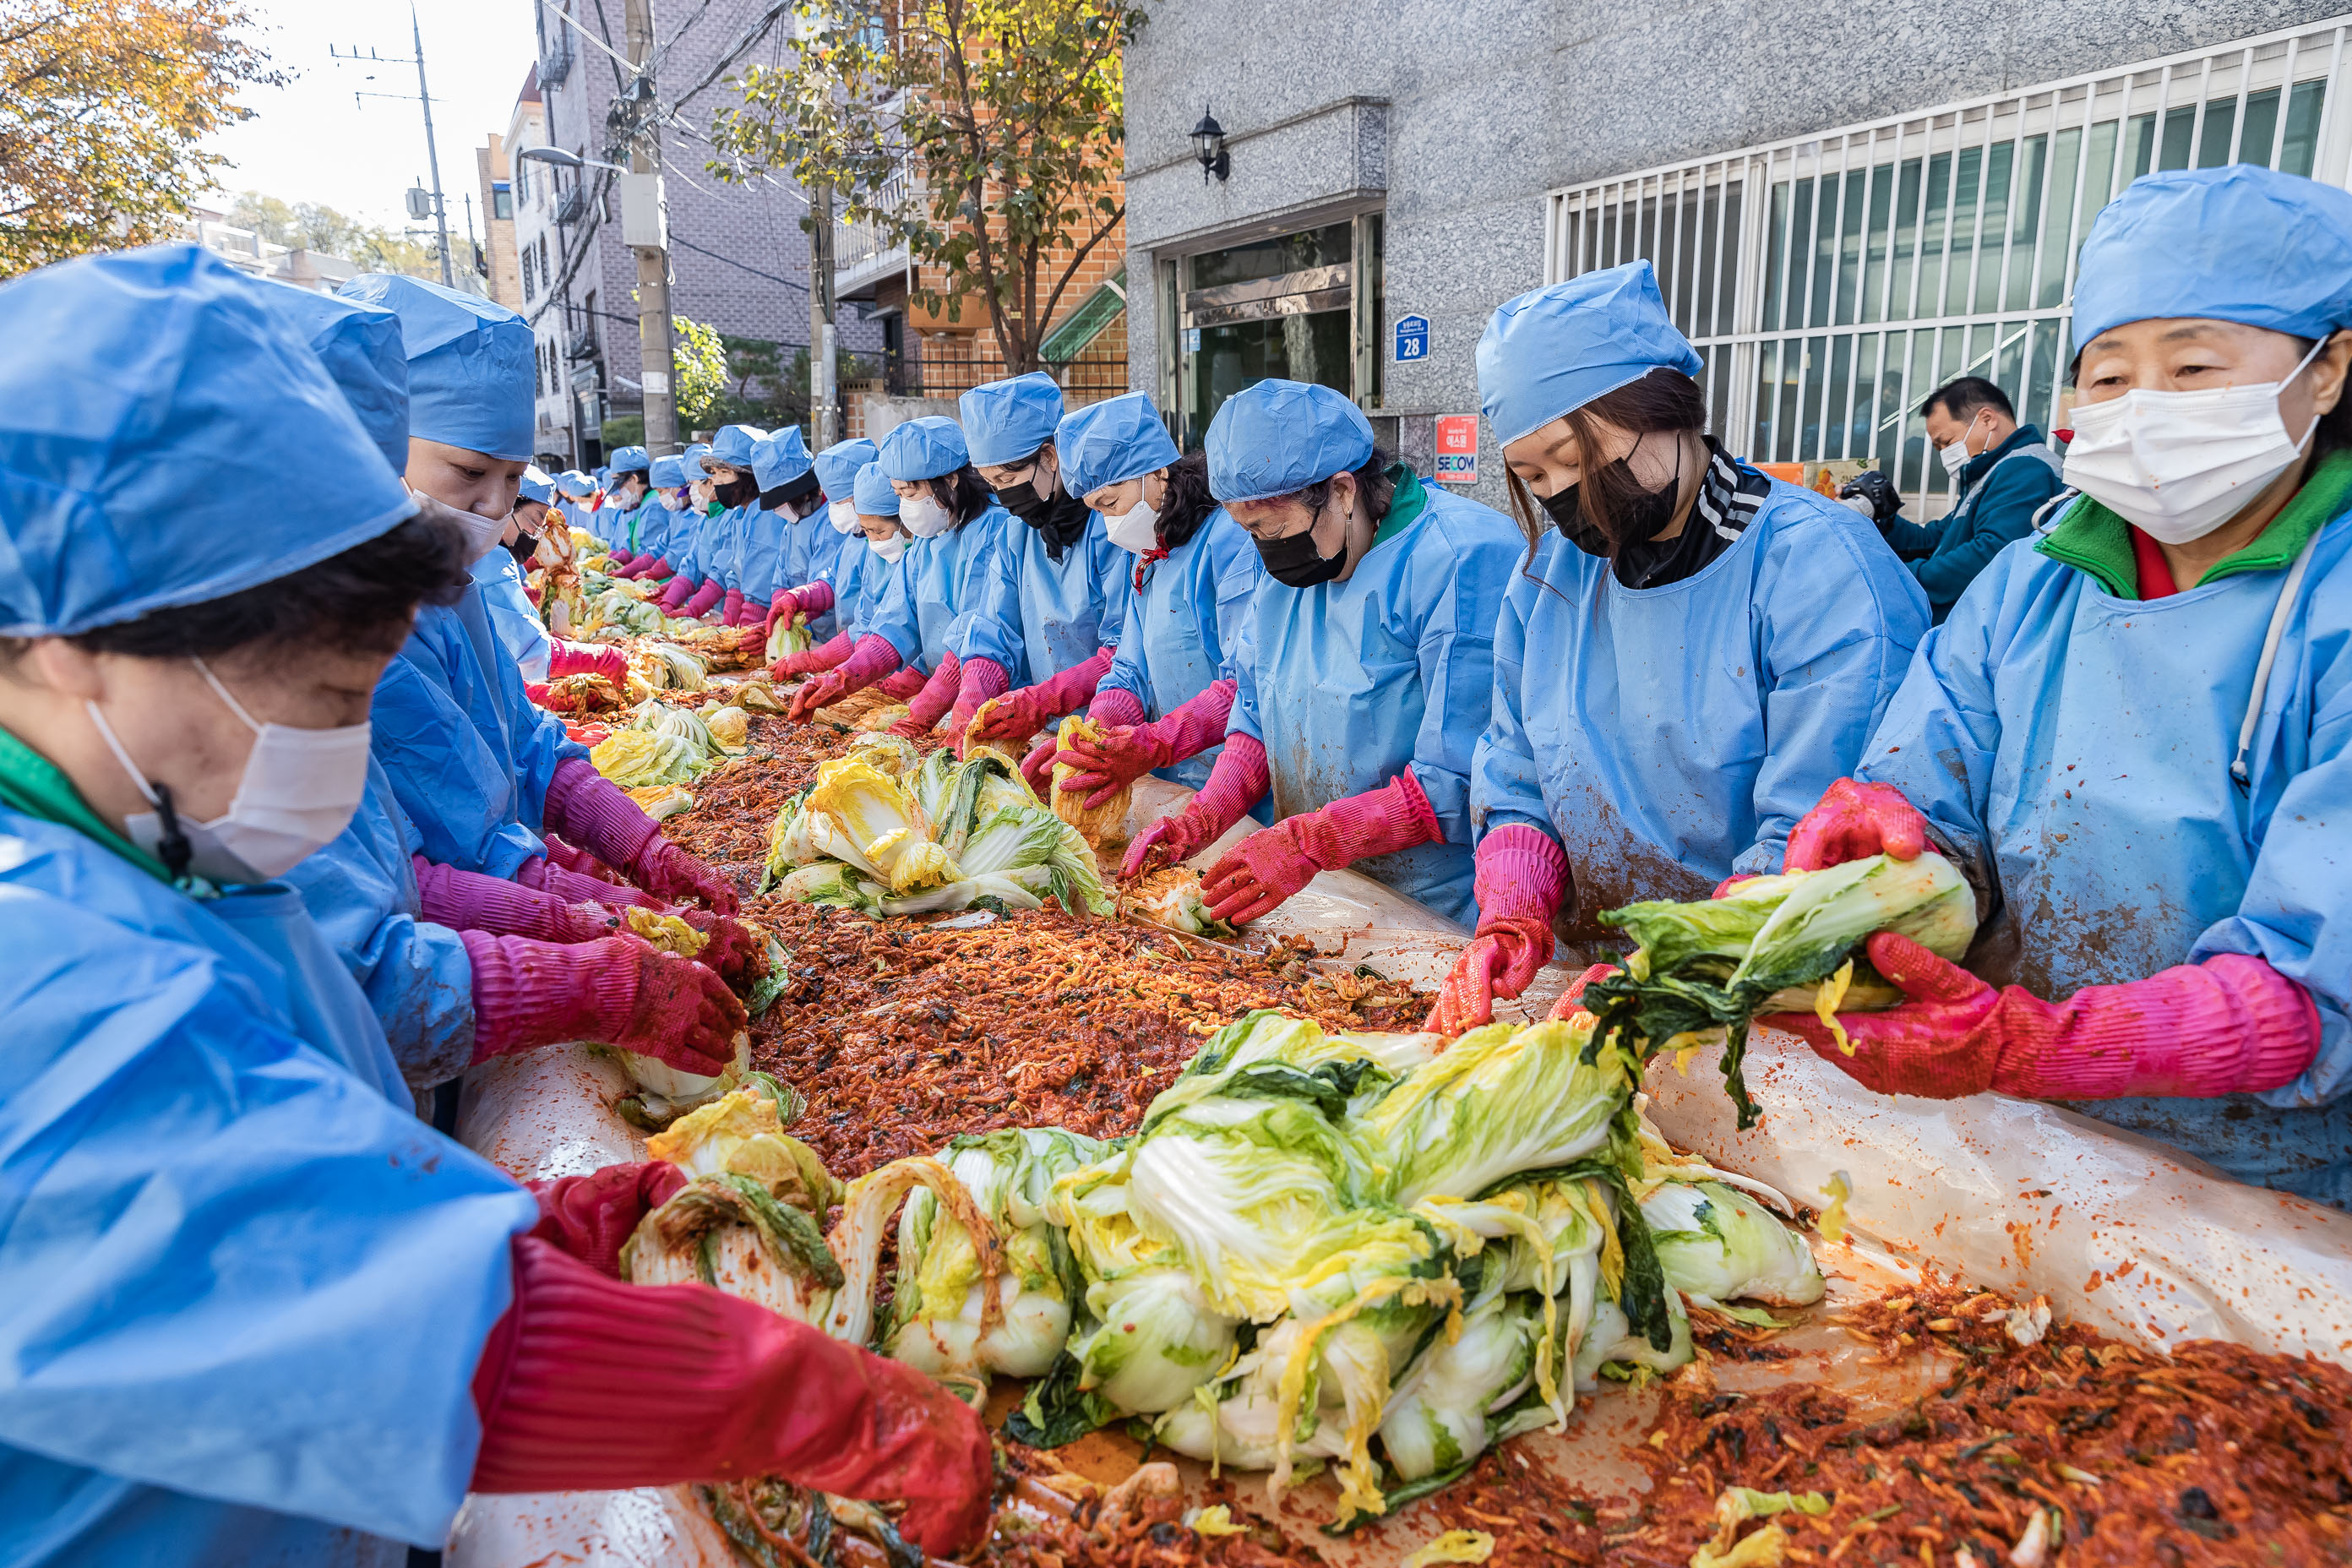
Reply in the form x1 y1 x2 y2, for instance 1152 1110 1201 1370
82 658 369 886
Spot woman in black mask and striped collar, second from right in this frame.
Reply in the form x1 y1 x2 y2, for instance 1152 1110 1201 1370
1430 261 1929 1032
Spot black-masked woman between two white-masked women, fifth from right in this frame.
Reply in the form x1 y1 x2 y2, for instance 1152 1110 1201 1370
950 372 1134 757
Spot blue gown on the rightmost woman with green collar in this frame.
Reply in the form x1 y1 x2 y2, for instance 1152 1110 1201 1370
1856 503 2352 1206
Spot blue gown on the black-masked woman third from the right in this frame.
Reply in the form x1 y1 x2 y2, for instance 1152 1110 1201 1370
1225 482 1527 926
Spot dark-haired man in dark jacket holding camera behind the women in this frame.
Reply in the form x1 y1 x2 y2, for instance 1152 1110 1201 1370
1848 376 2063 625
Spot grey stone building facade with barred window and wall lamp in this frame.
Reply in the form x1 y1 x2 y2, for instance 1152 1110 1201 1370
1127 0 2352 513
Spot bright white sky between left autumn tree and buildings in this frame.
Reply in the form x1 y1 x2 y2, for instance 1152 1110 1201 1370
204 0 539 232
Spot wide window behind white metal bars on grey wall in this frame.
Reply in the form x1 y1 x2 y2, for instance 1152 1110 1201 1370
1545 26 2352 496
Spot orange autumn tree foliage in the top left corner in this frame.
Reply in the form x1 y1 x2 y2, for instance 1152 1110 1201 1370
0 0 285 277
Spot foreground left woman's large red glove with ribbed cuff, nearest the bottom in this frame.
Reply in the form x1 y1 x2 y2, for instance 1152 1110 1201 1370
471 1237 995 1556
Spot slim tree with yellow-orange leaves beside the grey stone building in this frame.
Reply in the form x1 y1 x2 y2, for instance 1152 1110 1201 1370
710 0 1143 373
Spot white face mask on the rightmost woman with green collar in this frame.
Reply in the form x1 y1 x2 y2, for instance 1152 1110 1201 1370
2065 339 2326 546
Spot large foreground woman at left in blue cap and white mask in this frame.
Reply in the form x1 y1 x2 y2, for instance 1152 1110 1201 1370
0 247 990 1568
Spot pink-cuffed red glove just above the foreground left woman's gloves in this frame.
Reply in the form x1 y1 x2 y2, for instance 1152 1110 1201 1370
459 931 748 1076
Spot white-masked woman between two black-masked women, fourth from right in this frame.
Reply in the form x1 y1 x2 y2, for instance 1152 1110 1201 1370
1048 393 1266 804
